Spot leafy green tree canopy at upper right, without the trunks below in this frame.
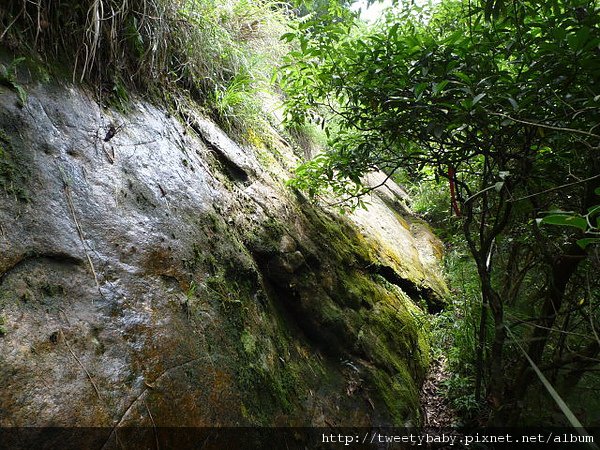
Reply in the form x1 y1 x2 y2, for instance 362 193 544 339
282 3 600 199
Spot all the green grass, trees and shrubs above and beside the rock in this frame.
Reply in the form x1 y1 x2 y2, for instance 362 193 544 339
0 0 600 425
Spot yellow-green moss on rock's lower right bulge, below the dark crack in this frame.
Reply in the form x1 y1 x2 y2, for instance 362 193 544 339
328 271 429 426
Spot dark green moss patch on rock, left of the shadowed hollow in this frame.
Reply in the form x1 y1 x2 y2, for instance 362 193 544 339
183 256 303 426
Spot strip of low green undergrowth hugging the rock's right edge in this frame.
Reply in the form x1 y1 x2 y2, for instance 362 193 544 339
408 172 491 424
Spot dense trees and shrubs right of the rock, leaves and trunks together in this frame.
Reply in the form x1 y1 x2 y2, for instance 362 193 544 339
283 0 600 424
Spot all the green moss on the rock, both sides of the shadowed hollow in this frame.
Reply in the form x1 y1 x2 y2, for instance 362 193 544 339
177 156 436 426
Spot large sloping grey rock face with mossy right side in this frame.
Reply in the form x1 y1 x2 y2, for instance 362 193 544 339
0 84 445 427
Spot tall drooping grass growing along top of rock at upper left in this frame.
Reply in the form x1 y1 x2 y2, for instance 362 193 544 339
0 0 289 133
